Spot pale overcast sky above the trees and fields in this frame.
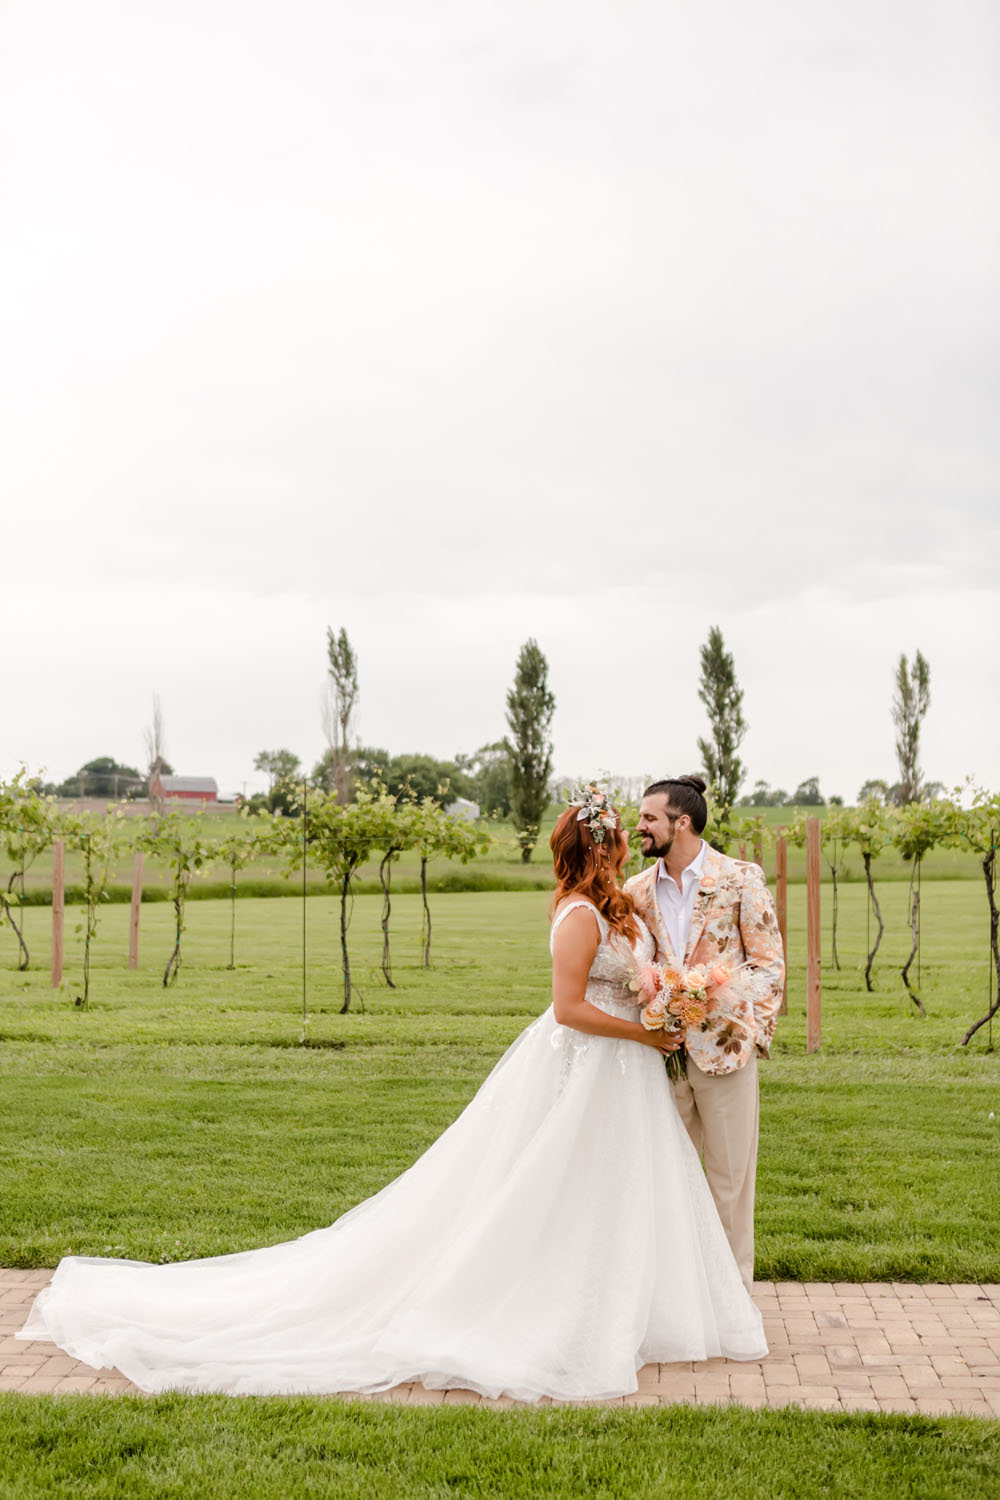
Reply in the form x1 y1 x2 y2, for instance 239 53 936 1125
0 0 1000 800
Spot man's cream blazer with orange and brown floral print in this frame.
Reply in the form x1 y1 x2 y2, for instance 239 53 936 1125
625 848 784 1074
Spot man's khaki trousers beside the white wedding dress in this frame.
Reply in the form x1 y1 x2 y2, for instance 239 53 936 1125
673 1056 760 1292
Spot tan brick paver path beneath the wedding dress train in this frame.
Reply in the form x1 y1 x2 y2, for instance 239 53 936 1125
0 1269 1000 1418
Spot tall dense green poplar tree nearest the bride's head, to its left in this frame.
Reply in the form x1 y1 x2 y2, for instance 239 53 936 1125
504 641 556 864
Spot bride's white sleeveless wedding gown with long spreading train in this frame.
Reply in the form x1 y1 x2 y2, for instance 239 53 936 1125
18 902 768 1401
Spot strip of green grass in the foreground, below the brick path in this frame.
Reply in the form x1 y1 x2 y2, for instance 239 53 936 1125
0 1395 1000 1500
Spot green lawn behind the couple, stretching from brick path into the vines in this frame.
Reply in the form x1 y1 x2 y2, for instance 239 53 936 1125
0 882 1000 1281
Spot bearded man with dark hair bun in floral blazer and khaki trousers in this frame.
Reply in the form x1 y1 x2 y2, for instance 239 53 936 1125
625 776 784 1290
